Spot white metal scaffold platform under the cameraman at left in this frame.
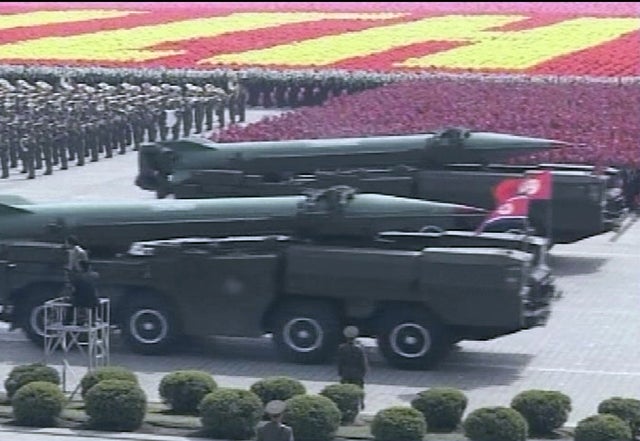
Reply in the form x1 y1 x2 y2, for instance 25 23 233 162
43 297 111 391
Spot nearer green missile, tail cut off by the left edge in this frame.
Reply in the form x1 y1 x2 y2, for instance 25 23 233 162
0 186 486 255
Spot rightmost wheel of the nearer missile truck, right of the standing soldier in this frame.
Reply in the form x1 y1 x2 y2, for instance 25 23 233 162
377 309 450 369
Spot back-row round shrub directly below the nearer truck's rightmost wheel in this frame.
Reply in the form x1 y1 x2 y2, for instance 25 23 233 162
411 387 468 432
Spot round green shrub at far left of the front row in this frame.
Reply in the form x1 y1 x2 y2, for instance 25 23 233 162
11 381 66 427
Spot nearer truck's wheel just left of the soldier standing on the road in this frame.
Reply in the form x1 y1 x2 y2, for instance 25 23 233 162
273 301 340 364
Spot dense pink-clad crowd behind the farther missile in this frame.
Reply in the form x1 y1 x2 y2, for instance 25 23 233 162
217 79 640 167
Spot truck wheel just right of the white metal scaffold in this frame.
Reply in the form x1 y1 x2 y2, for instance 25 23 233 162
120 294 180 355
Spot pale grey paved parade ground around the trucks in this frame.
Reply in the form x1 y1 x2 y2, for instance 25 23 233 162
0 107 640 423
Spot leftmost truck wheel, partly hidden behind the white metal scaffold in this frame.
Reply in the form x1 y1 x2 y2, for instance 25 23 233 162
16 285 62 347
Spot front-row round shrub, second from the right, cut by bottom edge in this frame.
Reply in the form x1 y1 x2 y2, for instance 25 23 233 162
462 407 527 441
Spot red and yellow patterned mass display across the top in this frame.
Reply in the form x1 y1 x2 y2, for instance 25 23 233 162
0 3 640 76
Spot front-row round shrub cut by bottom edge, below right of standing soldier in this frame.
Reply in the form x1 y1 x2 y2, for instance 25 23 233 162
371 406 427 441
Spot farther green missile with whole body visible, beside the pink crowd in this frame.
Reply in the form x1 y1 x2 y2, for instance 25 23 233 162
136 128 566 190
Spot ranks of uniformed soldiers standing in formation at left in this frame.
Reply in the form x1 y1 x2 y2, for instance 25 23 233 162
0 78 230 179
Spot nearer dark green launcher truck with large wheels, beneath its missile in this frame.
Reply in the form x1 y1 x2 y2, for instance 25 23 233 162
0 228 554 369
